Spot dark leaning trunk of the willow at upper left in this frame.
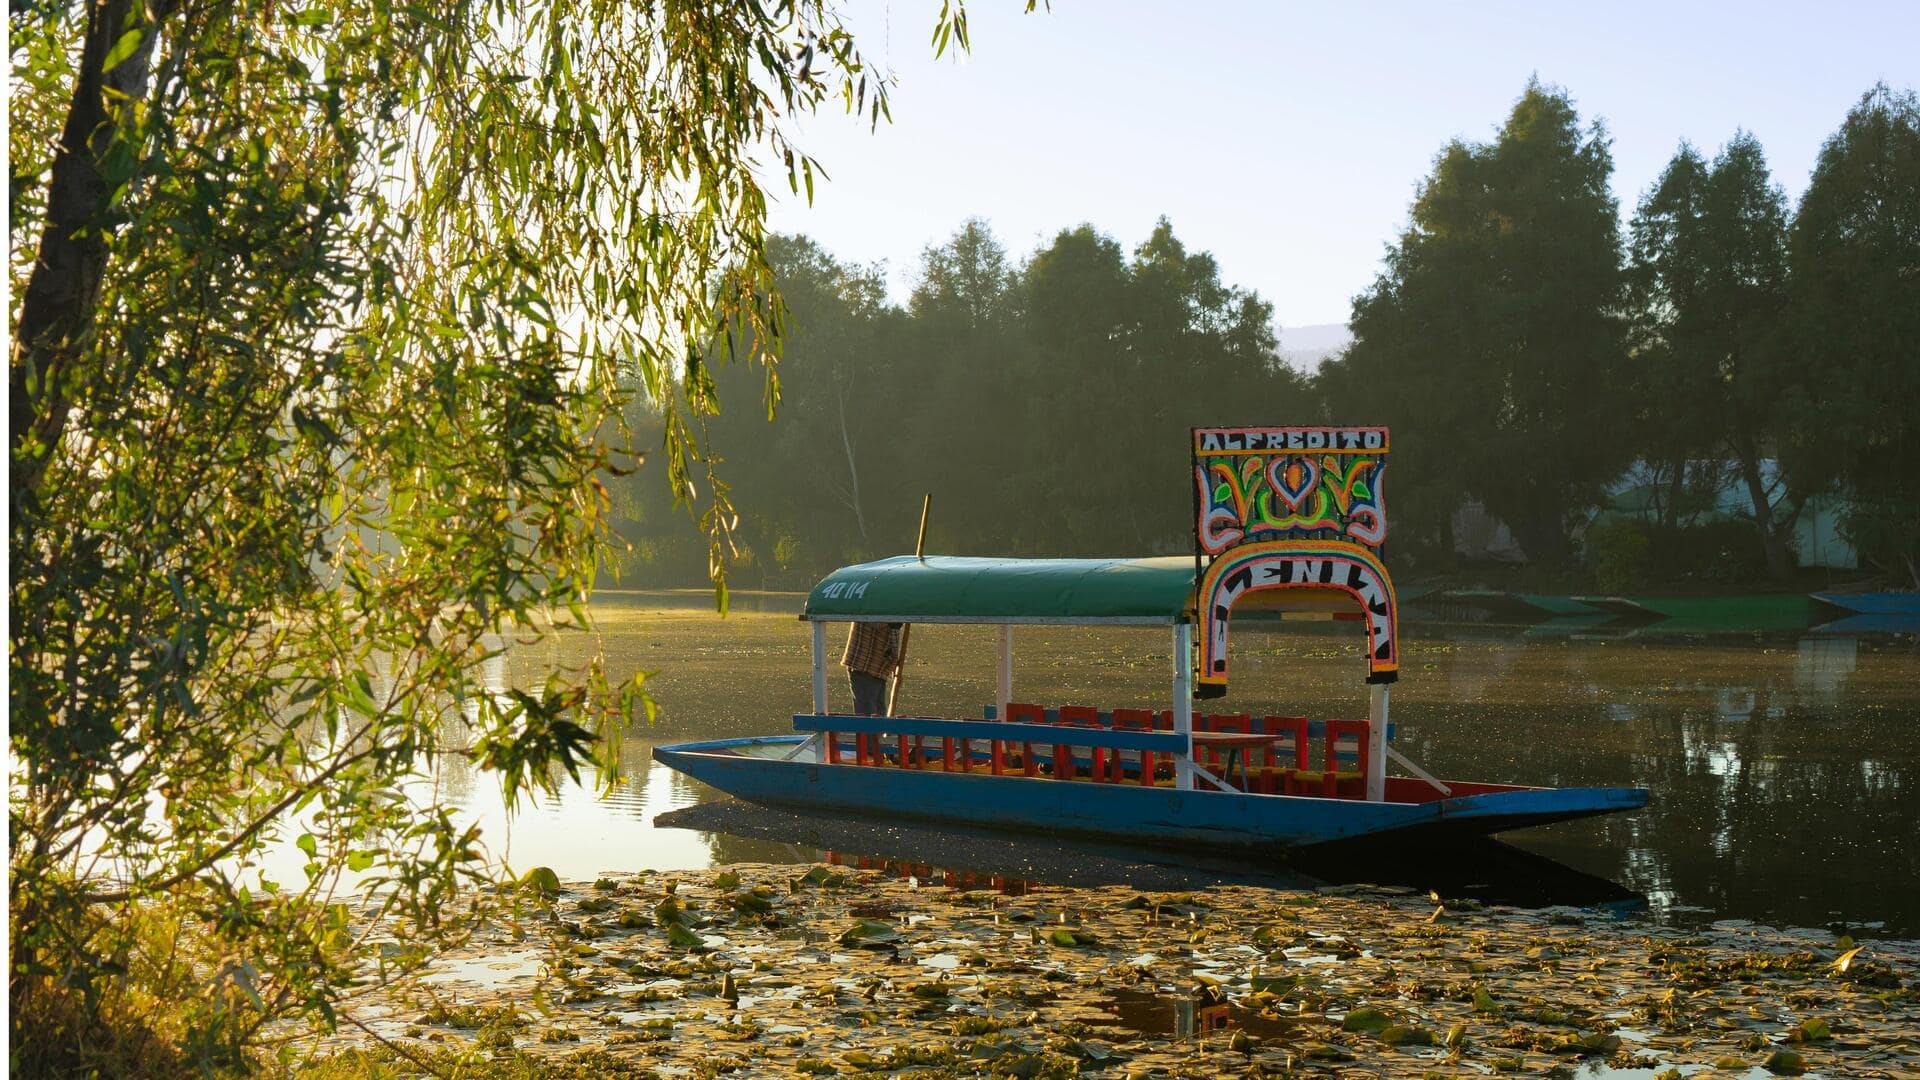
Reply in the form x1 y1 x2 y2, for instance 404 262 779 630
8 0 154 499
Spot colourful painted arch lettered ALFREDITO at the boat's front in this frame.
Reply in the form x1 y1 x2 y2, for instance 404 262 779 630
1192 427 1400 698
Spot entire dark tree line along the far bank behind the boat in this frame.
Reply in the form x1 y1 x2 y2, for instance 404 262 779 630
620 81 1920 584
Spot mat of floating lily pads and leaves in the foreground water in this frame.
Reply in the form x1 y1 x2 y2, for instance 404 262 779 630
319 865 1920 1080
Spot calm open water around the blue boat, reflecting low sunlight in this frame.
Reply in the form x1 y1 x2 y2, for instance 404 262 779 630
424 594 1920 936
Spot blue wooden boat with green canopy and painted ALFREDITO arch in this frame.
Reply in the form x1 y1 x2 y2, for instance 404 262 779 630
655 429 1647 849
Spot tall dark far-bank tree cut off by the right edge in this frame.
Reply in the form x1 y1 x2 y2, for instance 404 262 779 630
1788 85 1920 586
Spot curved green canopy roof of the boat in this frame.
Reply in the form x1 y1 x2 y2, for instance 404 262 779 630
801 555 1194 625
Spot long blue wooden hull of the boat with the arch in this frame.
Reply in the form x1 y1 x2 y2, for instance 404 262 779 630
653 736 1647 849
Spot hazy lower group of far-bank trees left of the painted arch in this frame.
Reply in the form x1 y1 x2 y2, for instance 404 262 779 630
618 219 1311 584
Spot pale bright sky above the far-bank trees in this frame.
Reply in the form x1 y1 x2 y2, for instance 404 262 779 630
772 0 1920 328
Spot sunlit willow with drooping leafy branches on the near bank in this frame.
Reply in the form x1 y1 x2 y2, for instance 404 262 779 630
8 0 966 1072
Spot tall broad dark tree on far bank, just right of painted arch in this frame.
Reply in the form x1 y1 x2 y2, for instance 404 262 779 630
1325 81 1630 565
